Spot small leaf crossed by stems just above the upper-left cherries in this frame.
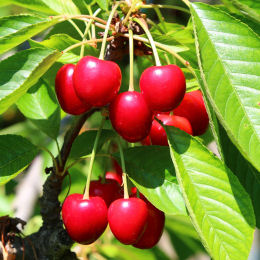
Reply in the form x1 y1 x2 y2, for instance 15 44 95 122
29 34 98 64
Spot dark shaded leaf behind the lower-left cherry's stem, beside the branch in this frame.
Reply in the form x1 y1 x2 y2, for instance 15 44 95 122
70 129 116 159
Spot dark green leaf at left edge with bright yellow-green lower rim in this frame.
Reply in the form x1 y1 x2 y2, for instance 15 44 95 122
0 135 38 185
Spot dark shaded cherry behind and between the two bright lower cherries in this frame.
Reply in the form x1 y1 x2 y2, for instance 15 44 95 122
89 179 121 207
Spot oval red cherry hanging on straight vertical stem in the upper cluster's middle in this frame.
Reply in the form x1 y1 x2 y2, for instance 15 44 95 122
109 91 152 143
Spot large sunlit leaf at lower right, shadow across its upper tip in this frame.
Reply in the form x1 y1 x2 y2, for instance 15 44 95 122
168 126 255 260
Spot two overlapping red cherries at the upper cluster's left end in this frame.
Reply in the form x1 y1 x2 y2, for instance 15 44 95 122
55 56 122 115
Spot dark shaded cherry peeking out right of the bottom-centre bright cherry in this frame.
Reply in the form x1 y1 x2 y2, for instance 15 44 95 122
134 194 165 249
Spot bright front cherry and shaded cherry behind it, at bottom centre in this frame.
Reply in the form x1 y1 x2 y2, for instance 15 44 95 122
108 191 165 249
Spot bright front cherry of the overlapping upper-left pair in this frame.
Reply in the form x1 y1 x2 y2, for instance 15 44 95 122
73 56 122 107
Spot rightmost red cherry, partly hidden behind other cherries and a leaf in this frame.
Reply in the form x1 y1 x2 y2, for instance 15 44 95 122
173 90 209 135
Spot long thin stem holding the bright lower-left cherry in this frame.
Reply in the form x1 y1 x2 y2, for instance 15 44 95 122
83 116 106 199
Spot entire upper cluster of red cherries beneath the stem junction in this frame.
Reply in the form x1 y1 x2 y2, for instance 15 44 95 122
55 56 209 145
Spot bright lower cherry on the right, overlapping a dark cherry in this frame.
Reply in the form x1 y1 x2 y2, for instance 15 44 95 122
108 198 148 245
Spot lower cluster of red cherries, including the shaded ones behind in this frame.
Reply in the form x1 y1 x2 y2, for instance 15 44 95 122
62 161 165 249
